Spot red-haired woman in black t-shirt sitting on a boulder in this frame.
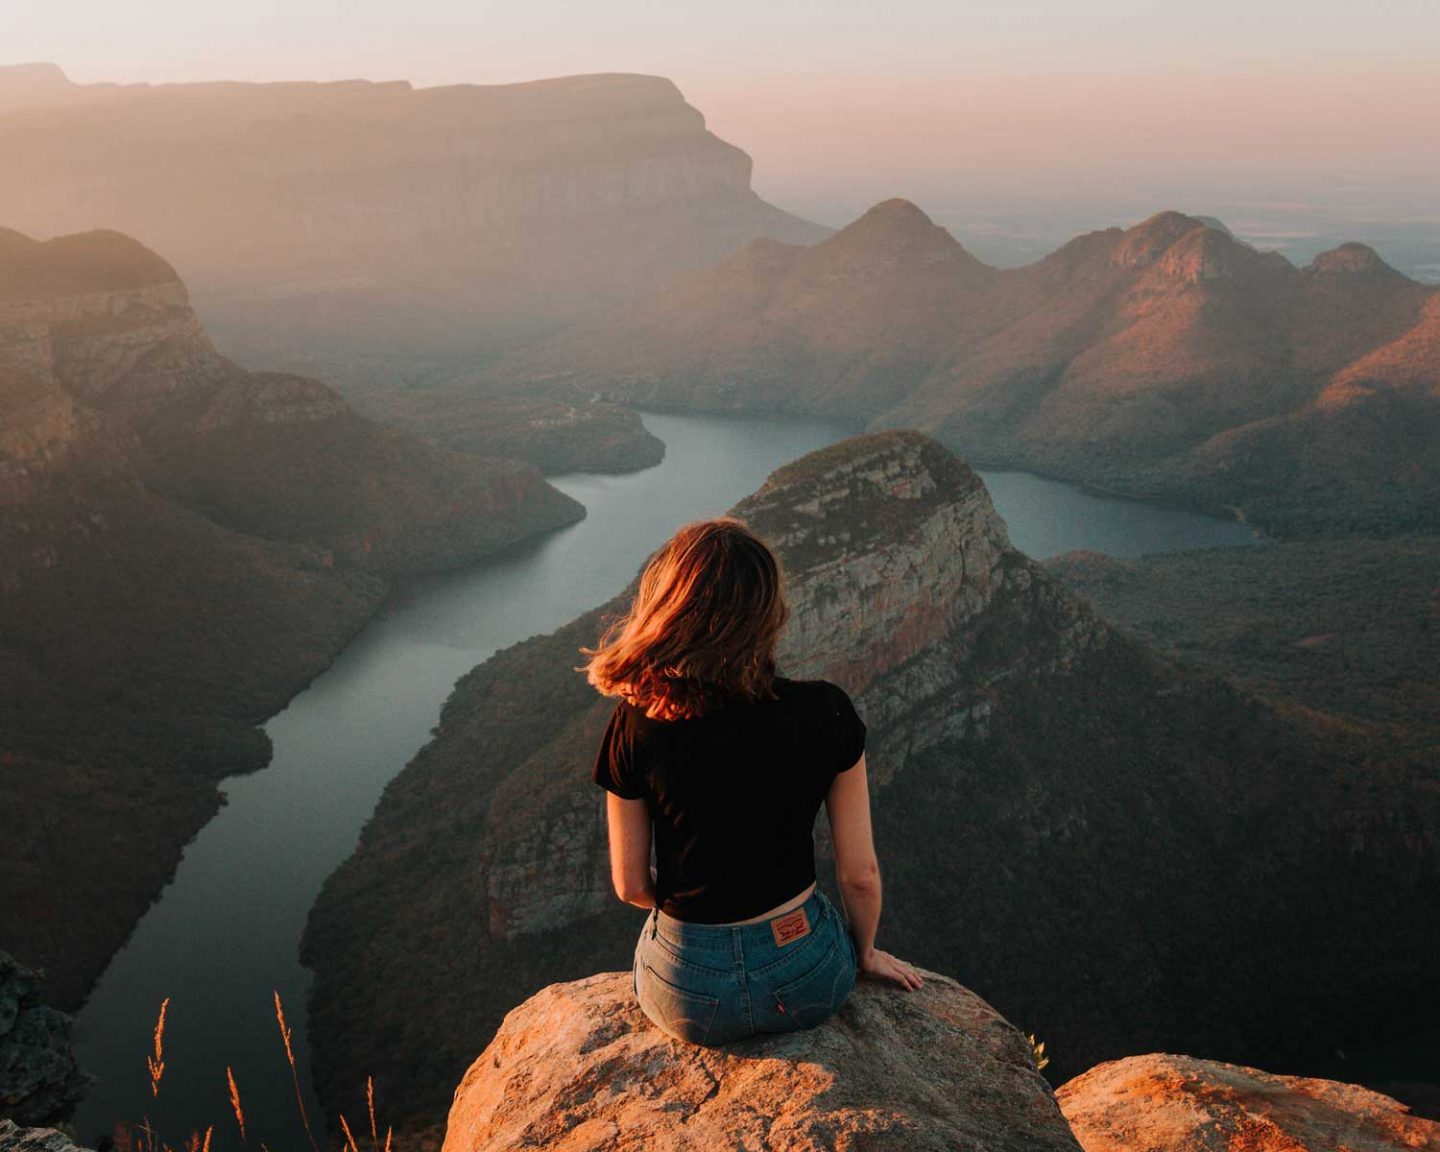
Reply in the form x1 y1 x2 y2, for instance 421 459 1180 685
583 518 920 1045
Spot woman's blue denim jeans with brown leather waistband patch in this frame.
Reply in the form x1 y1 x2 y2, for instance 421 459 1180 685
635 888 855 1047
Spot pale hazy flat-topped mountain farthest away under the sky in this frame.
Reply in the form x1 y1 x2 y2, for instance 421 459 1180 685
0 65 825 390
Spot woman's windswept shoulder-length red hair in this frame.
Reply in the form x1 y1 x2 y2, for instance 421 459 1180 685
580 517 789 720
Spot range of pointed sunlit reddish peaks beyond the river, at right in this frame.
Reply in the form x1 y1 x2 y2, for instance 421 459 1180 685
509 202 1440 534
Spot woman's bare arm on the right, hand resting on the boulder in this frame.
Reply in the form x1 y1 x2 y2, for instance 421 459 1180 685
825 753 920 989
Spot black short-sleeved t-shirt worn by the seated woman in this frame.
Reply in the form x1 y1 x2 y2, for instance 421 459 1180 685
592 677 865 924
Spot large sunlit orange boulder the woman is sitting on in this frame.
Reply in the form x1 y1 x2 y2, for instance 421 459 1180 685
444 972 1079 1152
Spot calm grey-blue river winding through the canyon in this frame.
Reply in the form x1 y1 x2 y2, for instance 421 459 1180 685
75 415 1251 1152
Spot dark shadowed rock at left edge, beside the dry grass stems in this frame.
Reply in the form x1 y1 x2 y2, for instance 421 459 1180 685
0 952 86 1123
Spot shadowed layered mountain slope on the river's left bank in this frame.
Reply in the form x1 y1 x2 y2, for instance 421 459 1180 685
0 230 583 1004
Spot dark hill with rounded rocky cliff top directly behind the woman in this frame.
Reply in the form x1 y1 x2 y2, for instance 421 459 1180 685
304 433 1440 1128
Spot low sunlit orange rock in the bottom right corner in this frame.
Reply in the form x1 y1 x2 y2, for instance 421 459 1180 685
1057 1054 1440 1152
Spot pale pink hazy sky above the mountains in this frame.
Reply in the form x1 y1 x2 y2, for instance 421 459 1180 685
0 0 1440 239
